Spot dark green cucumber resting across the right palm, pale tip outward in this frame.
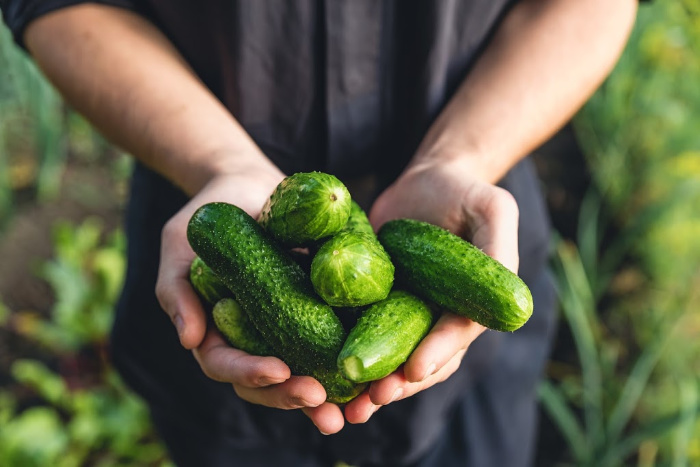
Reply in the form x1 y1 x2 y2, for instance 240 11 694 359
378 219 533 331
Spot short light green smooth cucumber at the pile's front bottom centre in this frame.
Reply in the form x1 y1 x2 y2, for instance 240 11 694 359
338 290 433 383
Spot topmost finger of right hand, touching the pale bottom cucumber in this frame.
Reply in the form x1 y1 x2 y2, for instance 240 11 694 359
403 312 486 382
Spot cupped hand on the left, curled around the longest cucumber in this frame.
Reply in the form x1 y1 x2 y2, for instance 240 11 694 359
156 170 344 433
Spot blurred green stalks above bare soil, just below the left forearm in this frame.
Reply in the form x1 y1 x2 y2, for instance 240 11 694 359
0 16 131 229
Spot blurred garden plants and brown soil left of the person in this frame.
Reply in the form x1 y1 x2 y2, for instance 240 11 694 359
0 11 171 467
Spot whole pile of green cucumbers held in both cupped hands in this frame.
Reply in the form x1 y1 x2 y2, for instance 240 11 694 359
187 172 533 403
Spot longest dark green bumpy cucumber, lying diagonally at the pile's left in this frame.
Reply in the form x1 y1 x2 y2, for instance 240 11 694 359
187 203 363 403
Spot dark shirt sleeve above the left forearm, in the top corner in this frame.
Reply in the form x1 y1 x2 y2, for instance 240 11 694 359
0 0 136 48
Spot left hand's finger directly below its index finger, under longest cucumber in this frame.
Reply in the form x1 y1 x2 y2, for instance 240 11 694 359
233 376 326 410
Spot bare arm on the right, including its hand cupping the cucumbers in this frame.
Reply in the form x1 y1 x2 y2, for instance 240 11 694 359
356 0 637 422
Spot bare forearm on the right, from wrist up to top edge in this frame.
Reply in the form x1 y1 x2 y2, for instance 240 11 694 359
412 0 637 182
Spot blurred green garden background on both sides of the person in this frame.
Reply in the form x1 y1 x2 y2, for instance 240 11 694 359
0 0 700 467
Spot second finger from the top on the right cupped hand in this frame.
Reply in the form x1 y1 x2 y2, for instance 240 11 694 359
367 349 466 407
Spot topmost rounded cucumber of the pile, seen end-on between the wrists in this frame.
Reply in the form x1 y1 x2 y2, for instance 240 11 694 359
260 172 351 246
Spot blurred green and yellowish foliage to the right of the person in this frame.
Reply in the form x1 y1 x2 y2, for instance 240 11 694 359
541 0 700 466
